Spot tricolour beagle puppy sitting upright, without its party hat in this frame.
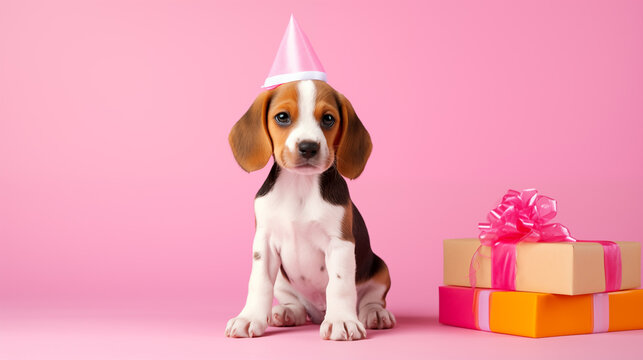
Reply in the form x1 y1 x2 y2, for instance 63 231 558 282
225 80 395 340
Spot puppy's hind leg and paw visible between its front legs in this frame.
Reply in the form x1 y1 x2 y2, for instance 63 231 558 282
269 272 306 326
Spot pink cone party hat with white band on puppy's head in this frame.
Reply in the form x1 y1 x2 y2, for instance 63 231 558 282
262 15 326 88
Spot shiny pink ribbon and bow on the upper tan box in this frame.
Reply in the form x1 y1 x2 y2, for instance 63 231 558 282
469 189 621 291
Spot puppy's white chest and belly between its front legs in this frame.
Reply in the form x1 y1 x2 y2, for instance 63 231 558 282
255 174 345 309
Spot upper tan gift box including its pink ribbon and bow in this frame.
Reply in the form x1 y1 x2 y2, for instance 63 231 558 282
444 189 641 295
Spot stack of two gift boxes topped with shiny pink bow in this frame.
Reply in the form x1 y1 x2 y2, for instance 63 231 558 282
439 190 643 337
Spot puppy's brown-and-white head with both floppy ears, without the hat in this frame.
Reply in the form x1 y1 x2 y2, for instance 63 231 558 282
228 80 373 179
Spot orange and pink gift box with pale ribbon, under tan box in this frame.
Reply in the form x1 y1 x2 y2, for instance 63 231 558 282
440 286 643 338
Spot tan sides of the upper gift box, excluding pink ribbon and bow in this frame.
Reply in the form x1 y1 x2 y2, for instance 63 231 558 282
443 238 641 295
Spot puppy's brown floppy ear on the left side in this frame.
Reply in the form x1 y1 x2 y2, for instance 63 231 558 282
228 90 272 172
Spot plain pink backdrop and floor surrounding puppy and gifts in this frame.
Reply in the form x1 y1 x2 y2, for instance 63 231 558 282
0 0 643 359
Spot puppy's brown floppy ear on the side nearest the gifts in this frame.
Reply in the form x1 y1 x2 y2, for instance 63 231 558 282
337 93 373 179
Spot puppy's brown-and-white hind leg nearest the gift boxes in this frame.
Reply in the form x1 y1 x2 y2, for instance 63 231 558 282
357 262 396 329
